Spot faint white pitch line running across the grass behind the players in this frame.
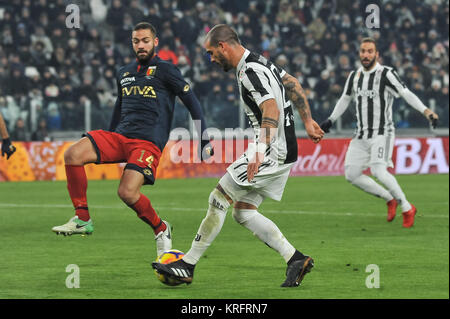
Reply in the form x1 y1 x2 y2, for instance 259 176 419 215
0 203 449 219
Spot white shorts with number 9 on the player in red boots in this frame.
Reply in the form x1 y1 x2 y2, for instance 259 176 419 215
344 134 394 169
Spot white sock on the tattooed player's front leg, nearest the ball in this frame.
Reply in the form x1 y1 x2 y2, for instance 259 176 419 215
183 189 230 265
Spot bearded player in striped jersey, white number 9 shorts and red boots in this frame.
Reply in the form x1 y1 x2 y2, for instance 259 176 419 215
320 38 438 228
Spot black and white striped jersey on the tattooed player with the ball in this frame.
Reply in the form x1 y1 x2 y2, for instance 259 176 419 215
236 50 298 164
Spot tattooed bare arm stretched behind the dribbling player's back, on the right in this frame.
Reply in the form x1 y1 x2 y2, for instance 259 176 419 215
282 73 324 143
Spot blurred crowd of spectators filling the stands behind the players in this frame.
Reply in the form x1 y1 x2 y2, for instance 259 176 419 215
0 0 449 141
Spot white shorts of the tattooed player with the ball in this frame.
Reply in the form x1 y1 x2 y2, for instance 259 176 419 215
219 146 294 207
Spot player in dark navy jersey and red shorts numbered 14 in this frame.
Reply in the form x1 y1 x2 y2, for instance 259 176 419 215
52 22 212 255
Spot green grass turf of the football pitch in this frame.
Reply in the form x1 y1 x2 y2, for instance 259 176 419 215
0 175 449 299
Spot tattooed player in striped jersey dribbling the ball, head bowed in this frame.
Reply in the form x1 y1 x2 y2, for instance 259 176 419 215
152 24 324 287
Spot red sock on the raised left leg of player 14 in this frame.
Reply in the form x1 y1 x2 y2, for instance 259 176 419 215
66 165 90 221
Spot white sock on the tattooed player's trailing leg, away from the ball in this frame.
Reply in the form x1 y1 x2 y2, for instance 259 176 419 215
233 208 295 262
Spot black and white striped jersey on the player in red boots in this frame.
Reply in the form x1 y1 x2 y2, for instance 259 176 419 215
338 63 407 139
